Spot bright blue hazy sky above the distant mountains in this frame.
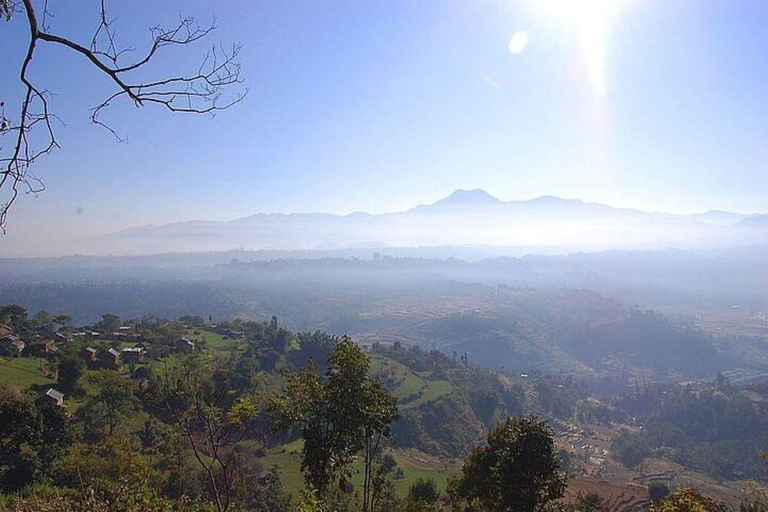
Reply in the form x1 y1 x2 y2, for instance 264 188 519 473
0 0 768 244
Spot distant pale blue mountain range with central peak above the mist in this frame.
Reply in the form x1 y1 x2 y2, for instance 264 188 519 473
58 190 768 254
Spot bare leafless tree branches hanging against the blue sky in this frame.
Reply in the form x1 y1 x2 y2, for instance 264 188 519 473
0 0 248 232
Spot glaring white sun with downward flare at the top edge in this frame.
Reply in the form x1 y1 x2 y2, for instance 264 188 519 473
536 0 620 94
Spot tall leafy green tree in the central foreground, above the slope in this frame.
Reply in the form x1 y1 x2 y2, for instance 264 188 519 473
270 336 398 504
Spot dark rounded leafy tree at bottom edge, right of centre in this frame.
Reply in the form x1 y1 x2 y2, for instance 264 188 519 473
451 416 566 512
